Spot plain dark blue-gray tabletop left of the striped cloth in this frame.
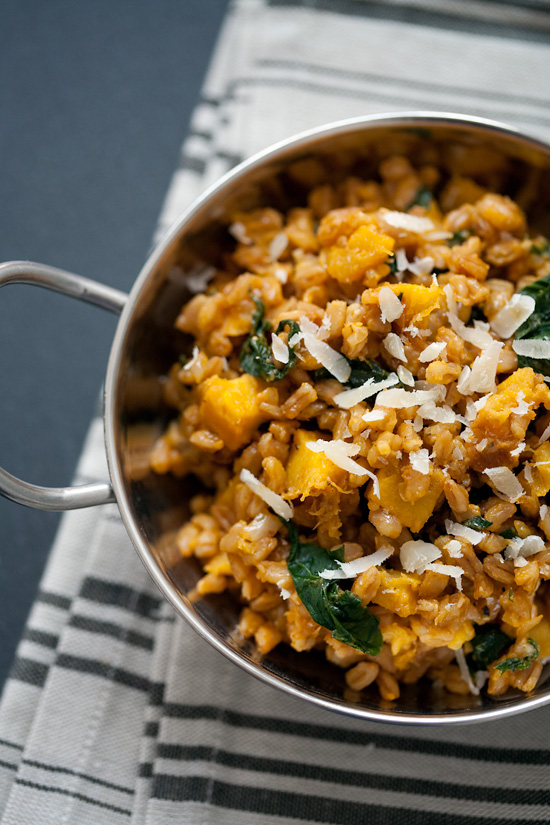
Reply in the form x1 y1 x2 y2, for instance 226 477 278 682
0 0 227 685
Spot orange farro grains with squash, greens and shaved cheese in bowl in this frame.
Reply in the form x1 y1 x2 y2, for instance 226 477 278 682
151 155 550 701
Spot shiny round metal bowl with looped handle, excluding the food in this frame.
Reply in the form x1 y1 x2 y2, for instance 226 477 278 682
0 112 550 725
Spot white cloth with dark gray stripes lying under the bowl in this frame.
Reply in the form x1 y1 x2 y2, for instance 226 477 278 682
0 0 550 825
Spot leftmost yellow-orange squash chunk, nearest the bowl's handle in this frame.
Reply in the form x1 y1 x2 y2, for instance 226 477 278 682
199 374 265 450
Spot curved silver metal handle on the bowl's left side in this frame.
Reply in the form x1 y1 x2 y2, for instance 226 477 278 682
0 261 128 510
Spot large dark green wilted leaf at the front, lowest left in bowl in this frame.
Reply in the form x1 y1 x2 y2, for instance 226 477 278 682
285 521 382 656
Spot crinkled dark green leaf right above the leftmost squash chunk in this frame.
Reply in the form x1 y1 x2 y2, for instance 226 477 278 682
239 295 300 381
